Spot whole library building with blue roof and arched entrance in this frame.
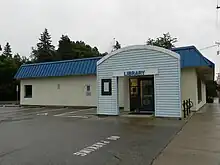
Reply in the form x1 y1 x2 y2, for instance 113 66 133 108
15 45 215 117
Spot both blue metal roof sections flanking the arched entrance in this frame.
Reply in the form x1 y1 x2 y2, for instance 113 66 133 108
15 46 215 79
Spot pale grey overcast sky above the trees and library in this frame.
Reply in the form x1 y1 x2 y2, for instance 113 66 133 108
0 0 220 76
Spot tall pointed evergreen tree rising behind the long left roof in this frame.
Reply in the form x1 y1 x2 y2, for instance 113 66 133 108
31 29 55 62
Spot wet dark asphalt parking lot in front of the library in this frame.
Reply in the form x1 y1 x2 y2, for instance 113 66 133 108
0 107 185 165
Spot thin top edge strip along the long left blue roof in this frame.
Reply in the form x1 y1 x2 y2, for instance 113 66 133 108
22 56 102 66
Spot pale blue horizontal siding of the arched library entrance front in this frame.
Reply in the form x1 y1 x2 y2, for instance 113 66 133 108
97 49 181 117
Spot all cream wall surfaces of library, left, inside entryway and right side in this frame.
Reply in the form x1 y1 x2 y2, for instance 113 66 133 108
20 68 206 111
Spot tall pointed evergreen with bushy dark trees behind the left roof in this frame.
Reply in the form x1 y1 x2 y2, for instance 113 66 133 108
30 29 103 62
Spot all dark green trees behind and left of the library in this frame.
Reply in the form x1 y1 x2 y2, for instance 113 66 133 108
0 29 177 101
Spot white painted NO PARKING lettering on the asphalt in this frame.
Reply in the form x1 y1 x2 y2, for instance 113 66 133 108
73 136 120 156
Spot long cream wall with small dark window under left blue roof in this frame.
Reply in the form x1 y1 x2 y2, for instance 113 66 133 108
21 76 97 106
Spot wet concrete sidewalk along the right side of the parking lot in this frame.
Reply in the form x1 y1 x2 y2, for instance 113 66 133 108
153 103 220 165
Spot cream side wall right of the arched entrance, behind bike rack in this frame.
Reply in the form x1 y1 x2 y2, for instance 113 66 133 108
181 68 206 111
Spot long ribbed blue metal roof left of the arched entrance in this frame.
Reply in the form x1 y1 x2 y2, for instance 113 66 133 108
15 57 101 79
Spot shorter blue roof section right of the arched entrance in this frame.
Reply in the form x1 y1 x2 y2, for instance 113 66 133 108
172 46 215 68
